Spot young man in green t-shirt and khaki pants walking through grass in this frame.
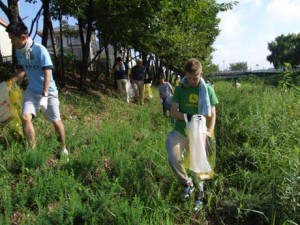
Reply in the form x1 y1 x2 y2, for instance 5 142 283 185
166 59 218 210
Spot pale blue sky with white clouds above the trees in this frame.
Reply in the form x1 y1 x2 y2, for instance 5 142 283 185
0 0 300 70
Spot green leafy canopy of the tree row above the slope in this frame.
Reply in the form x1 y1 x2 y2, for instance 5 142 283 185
0 0 236 76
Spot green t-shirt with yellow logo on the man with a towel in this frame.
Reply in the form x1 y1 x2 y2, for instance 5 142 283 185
172 85 219 136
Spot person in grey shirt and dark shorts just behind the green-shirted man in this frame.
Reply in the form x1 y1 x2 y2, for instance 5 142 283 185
158 76 174 116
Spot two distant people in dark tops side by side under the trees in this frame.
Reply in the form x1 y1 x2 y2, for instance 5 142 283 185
113 57 152 105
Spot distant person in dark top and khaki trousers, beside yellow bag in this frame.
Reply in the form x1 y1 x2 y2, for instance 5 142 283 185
130 59 146 105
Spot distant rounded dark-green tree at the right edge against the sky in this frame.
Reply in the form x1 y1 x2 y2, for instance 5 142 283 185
267 33 300 69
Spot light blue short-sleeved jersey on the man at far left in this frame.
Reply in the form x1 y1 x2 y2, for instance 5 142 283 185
16 42 57 94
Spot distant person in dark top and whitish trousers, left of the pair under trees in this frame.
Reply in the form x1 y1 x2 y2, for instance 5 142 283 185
113 57 130 103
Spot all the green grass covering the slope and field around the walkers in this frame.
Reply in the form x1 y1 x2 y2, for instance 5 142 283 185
0 82 300 225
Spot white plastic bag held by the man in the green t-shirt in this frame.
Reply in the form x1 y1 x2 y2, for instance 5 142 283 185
184 114 213 176
